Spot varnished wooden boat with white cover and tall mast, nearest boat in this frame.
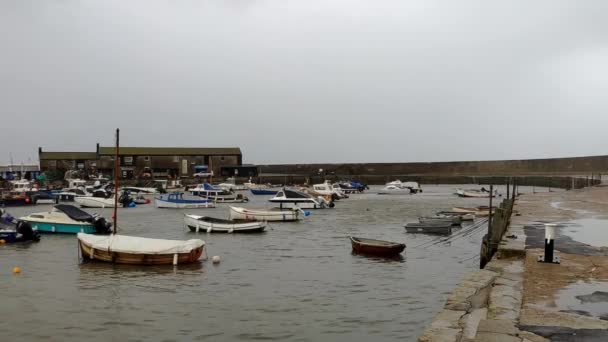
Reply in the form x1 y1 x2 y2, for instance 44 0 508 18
77 233 205 265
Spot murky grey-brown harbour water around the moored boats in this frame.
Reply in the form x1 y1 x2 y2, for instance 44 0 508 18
0 186 540 341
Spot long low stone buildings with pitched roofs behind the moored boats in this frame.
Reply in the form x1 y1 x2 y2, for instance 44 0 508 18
38 144 243 179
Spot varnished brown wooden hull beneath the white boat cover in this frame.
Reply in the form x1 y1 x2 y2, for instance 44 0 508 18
78 240 205 265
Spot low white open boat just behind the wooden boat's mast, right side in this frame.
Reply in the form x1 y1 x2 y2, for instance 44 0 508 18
184 214 266 233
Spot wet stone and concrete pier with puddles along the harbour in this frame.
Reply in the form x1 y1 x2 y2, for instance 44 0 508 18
419 186 608 342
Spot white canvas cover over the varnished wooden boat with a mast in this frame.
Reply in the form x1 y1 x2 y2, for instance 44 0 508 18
78 233 205 254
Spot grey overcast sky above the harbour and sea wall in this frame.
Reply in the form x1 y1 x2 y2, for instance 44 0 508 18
0 0 608 163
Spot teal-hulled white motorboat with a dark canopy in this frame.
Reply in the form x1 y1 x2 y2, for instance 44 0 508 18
19 204 112 234
